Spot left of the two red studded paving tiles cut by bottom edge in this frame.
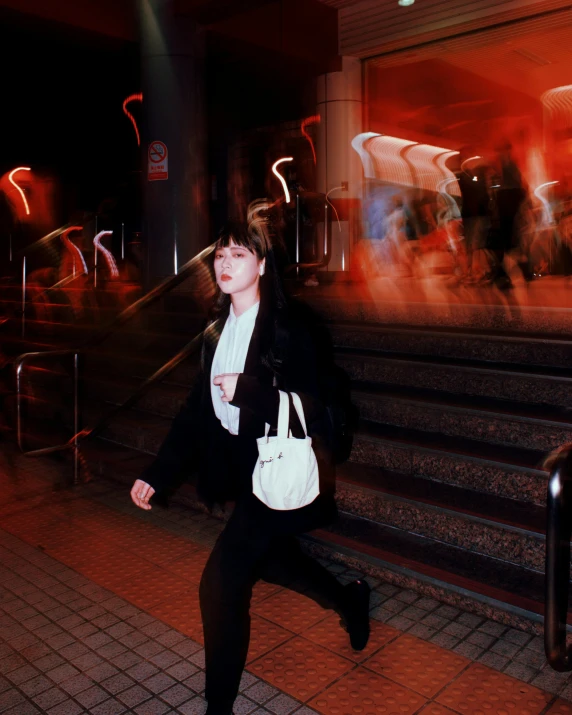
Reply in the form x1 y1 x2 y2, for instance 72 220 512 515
308 667 426 715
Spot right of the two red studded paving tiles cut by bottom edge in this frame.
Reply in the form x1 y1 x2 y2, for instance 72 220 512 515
436 663 552 715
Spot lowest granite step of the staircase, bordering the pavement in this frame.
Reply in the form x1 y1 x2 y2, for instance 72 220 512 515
304 513 572 633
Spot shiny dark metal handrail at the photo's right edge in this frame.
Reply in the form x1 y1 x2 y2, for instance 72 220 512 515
544 444 572 672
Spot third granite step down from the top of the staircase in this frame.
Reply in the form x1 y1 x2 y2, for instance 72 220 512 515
352 383 572 451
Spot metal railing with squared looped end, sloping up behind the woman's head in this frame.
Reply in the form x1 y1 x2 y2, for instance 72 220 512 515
14 244 214 484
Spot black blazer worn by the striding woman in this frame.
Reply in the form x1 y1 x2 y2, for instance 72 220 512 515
141 303 337 533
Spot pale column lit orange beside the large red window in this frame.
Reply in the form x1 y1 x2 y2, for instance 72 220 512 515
316 57 363 271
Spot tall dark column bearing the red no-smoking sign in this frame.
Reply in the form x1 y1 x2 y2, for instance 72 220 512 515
139 0 208 286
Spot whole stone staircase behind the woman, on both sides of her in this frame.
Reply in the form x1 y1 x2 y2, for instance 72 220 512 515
8 295 572 632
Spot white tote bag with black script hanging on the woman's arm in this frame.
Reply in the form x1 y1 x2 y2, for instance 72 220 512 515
252 390 320 511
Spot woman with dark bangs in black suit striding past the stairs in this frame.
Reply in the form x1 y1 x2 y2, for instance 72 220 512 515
131 221 369 715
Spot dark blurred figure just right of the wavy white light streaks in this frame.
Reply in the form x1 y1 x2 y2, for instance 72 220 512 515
457 146 489 283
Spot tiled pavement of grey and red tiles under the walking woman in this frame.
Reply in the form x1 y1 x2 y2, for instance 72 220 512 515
0 448 572 715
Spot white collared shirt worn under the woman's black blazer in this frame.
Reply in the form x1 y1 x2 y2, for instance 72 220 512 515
211 303 260 434
